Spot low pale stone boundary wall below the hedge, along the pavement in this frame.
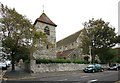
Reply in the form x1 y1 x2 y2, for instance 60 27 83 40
31 60 88 73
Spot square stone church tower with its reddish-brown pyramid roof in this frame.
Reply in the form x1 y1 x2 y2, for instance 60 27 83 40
33 12 57 59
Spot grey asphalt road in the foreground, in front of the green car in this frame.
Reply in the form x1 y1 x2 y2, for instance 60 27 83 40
28 71 119 83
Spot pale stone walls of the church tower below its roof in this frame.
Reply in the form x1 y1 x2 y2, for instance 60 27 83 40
33 21 56 59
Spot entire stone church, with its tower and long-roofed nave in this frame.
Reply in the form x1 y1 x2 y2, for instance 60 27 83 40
33 12 91 60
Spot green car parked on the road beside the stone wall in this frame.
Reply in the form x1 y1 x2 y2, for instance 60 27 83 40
83 64 104 73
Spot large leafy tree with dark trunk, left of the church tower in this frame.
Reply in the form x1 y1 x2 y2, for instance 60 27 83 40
0 4 46 71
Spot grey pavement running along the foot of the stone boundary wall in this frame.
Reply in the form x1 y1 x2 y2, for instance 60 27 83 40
3 67 82 80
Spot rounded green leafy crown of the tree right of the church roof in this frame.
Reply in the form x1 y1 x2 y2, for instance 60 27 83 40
85 19 116 48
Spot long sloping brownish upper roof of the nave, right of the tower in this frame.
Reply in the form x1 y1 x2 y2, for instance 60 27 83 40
57 30 81 47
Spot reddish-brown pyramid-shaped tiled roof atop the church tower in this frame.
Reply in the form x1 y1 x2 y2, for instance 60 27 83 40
34 13 57 27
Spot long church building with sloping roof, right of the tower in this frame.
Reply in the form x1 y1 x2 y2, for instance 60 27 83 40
56 29 91 61
